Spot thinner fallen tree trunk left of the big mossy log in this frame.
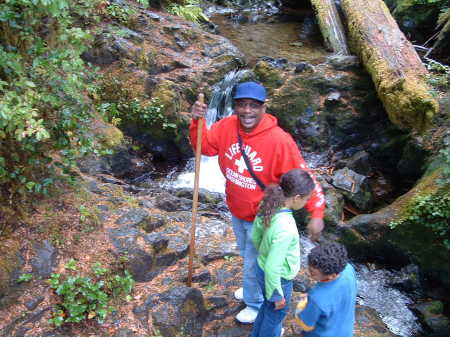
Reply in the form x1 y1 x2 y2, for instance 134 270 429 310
311 0 350 55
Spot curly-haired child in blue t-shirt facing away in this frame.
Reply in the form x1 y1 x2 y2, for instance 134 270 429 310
295 242 356 337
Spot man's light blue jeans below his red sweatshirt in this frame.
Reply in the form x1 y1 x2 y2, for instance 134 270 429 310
231 216 264 310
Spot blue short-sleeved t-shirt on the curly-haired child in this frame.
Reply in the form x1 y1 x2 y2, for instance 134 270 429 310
298 264 356 337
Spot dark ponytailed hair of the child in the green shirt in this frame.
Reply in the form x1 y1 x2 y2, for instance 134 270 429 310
258 169 314 228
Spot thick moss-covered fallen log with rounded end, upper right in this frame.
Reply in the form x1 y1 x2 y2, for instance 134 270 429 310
342 0 439 131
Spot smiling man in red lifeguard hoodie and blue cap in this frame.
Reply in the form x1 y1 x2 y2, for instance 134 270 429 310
189 82 325 324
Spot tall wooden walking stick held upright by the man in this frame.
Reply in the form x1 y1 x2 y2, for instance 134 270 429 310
187 94 204 287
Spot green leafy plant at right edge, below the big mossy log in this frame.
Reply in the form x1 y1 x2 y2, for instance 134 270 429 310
389 187 450 250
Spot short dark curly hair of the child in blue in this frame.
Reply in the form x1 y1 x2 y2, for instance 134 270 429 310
308 241 348 275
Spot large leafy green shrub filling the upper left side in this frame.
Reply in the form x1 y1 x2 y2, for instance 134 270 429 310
0 0 101 201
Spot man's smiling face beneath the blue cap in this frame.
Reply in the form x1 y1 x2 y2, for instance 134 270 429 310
234 98 266 132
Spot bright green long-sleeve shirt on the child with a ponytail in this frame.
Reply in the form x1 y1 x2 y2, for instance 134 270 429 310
252 208 300 300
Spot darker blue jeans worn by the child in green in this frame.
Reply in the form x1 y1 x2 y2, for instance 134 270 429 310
250 266 293 337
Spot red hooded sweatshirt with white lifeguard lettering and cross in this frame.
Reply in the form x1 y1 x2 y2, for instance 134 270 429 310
189 113 325 221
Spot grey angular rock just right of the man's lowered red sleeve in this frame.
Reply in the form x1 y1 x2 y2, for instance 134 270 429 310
333 168 373 210
